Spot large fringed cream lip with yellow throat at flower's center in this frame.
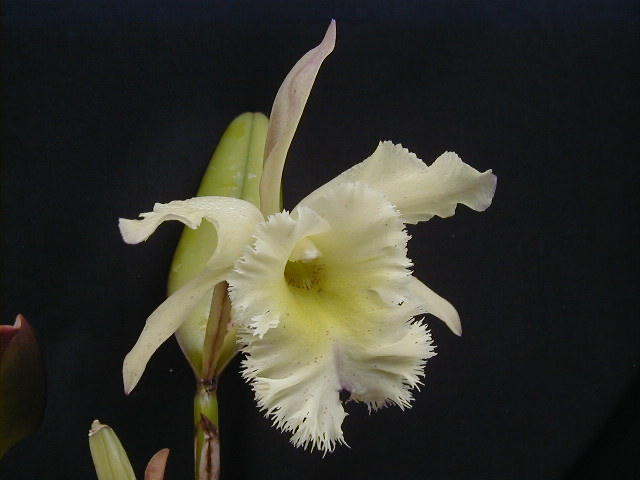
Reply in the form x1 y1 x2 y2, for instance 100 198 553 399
228 183 433 452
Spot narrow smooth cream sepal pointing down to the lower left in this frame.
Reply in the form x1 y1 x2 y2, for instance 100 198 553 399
122 267 229 394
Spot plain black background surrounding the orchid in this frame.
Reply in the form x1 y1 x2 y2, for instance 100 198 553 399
0 0 640 480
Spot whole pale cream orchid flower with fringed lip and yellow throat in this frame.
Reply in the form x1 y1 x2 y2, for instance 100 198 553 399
120 22 496 452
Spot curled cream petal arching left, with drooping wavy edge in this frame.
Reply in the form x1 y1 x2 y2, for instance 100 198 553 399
120 197 264 268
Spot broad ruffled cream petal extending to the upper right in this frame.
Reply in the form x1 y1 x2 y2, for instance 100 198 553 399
301 142 497 223
